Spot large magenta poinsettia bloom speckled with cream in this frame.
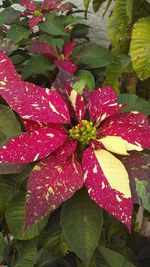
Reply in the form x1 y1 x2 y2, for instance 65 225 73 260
0 55 150 229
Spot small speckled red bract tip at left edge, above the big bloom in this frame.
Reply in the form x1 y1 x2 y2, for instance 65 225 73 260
0 53 20 84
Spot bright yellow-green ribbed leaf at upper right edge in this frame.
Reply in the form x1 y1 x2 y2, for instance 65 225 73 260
130 17 150 80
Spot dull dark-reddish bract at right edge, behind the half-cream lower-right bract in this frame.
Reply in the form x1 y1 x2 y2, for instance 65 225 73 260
117 151 150 204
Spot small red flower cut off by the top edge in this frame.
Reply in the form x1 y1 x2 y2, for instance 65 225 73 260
20 0 73 29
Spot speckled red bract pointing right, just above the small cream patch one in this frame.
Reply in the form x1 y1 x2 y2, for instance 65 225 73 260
100 112 150 150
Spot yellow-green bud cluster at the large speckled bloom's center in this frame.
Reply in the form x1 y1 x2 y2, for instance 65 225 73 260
69 120 96 145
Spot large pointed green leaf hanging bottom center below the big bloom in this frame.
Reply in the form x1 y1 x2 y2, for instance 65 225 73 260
61 190 103 265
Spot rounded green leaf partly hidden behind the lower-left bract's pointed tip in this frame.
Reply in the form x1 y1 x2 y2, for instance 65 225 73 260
6 192 47 240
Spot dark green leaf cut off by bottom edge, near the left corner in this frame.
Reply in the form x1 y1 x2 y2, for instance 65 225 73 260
10 240 37 267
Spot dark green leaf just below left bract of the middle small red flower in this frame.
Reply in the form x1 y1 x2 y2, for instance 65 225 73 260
22 55 55 80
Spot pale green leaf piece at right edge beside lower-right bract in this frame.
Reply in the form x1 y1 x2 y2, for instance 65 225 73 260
135 179 150 212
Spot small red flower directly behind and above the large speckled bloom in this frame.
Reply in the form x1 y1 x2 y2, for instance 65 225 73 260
29 41 77 74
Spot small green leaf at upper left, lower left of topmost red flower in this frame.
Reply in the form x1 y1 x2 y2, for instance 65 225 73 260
7 25 30 43
